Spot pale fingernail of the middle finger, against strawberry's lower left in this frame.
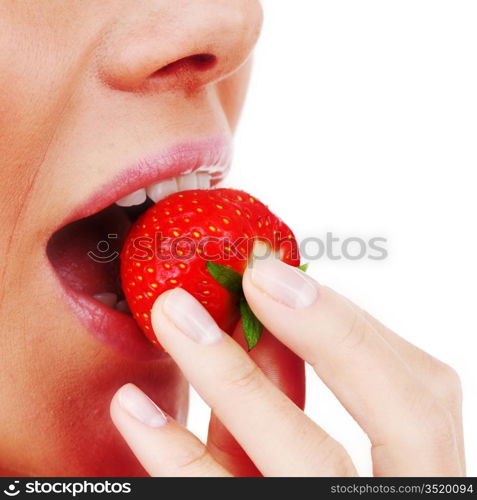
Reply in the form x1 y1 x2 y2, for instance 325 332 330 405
162 288 223 344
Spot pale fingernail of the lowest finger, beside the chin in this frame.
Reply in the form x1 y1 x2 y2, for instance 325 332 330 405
118 384 167 427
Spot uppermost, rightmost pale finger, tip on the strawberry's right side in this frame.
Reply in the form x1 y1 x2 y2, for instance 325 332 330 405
243 257 460 475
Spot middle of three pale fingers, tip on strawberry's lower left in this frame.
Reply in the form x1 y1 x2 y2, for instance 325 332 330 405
151 288 356 476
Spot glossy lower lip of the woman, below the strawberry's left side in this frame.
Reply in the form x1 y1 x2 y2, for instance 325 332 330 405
59 285 165 361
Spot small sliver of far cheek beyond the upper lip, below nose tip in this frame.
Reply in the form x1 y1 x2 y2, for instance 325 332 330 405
217 60 252 130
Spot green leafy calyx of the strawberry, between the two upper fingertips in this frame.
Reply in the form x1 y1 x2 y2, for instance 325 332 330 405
206 261 308 351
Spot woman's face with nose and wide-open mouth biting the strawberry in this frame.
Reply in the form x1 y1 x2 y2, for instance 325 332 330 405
0 0 261 476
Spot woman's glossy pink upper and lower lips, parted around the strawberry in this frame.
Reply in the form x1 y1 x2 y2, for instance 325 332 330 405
48 136 232 361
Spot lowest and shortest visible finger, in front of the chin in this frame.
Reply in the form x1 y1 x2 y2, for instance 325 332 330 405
110 384 230 477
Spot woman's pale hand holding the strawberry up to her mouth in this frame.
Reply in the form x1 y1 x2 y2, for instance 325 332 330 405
111 254 465 476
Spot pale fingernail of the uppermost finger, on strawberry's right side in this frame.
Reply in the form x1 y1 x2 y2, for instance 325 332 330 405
250 250 318 309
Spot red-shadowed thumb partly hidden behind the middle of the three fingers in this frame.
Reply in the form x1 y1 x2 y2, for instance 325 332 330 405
207 324 305 477
